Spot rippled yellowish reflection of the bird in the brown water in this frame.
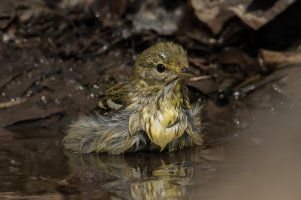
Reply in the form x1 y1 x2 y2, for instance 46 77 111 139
66 148 217 199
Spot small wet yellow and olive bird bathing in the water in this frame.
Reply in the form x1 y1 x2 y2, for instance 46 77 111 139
63 42 203 154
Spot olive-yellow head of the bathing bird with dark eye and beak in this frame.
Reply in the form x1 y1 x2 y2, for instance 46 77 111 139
134 42 193 87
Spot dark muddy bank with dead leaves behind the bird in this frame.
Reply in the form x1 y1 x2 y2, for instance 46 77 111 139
0 0 301 134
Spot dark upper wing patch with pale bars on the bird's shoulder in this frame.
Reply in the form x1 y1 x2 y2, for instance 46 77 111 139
98 83 129 111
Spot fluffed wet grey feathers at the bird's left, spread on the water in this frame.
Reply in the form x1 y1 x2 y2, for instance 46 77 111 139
63 112 144 154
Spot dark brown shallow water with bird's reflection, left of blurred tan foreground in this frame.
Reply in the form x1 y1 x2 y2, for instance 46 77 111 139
0 101 234 199
